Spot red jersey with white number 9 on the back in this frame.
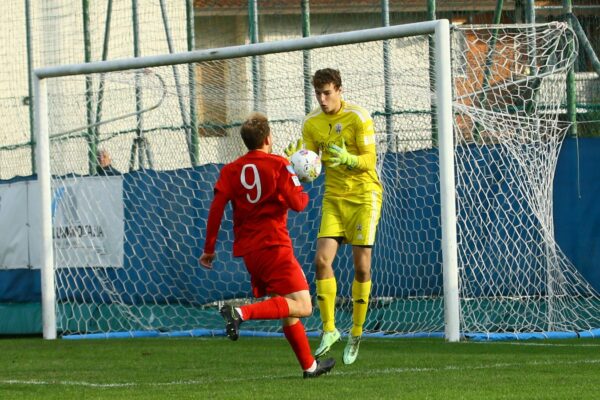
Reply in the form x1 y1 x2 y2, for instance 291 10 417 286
204 150 308 257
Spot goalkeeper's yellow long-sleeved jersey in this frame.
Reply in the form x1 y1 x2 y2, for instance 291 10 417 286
302 100 382 195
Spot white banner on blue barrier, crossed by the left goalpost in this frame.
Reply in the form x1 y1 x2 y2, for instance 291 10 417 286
0 176 124 269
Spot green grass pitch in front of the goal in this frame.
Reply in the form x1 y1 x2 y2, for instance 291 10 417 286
0 337 600 400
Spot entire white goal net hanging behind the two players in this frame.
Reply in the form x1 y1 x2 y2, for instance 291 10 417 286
35 23 600 335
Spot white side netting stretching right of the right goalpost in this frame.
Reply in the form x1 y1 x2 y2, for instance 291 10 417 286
455 24 600 332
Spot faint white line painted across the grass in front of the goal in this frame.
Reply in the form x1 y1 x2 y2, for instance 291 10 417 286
0 359 600 388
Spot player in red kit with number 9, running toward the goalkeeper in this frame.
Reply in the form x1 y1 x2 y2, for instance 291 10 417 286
200 113 335 378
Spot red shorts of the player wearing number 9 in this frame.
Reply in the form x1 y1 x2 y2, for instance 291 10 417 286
244 246 308 298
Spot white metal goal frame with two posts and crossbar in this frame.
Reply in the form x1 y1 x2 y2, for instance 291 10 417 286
33 19 460 342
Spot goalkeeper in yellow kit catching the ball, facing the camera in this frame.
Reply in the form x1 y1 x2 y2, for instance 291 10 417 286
286 68 383 364
